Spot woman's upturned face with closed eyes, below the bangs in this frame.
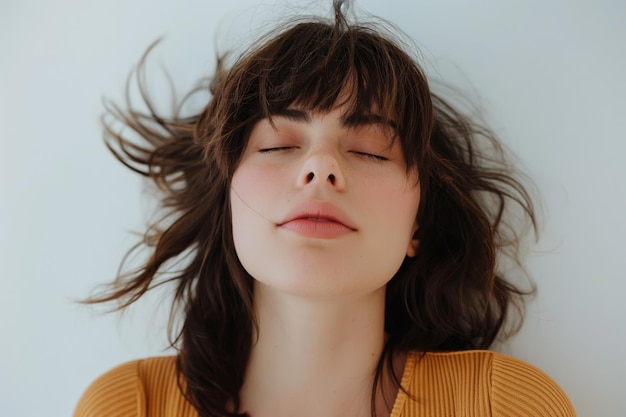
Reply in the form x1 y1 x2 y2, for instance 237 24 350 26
230 107 420 297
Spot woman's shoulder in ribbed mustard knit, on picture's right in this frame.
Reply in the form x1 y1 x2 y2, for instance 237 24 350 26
403 350 575 417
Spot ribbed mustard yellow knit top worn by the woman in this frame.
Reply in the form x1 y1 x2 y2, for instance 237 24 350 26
74 350 575 417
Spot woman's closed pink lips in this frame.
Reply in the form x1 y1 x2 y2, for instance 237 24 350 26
278 201 357 238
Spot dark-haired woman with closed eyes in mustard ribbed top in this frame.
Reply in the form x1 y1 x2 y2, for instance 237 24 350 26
75 2 574 417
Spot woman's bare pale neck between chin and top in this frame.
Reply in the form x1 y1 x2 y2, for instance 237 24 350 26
241 283 392 417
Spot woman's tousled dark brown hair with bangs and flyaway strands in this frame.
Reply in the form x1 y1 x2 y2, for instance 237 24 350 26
88 6 535 416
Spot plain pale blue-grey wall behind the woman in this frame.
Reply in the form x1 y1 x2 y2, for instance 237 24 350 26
0 0 626 417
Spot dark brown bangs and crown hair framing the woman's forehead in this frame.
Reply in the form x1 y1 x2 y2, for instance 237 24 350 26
206 16 434 178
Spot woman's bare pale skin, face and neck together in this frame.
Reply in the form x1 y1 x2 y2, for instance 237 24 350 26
231 102 420 417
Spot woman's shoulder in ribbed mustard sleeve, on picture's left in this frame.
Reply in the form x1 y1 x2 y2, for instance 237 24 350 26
74 356 193 417
